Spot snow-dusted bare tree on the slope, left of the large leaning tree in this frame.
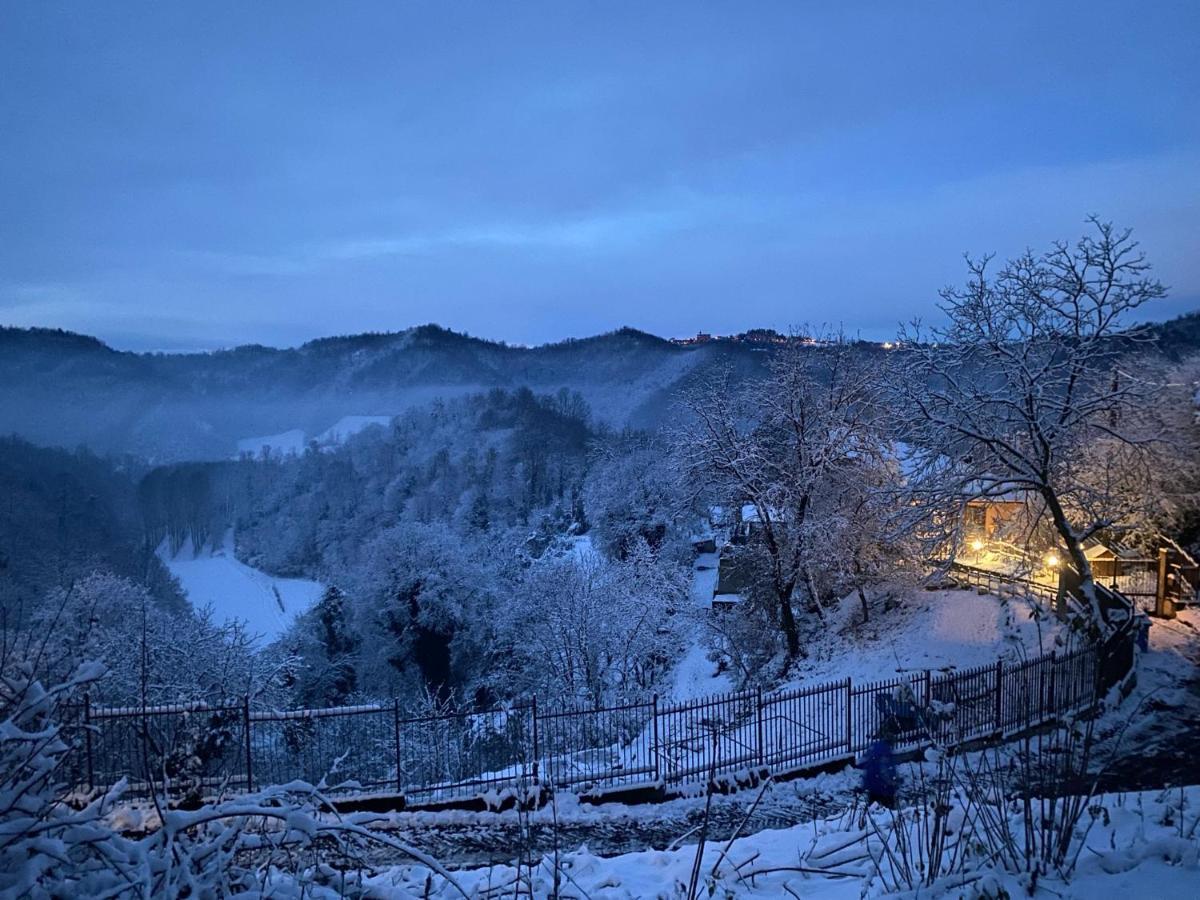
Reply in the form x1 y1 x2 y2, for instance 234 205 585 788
676 334 882 665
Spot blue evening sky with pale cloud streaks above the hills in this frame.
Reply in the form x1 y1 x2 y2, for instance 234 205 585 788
0 0 1200 349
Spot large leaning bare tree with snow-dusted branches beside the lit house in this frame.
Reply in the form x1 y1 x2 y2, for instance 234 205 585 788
898 217 1165 622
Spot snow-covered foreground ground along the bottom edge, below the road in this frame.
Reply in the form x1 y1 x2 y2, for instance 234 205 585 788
370 787 1200 900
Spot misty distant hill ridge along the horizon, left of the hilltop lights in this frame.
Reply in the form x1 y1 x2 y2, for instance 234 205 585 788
0 325 767 462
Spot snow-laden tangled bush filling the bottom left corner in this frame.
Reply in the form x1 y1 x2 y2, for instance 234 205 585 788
0 662 463 898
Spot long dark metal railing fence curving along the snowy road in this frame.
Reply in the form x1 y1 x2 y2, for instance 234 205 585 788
72 630 1134 803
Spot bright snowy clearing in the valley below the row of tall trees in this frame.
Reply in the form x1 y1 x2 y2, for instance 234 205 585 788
158 530 324 643
